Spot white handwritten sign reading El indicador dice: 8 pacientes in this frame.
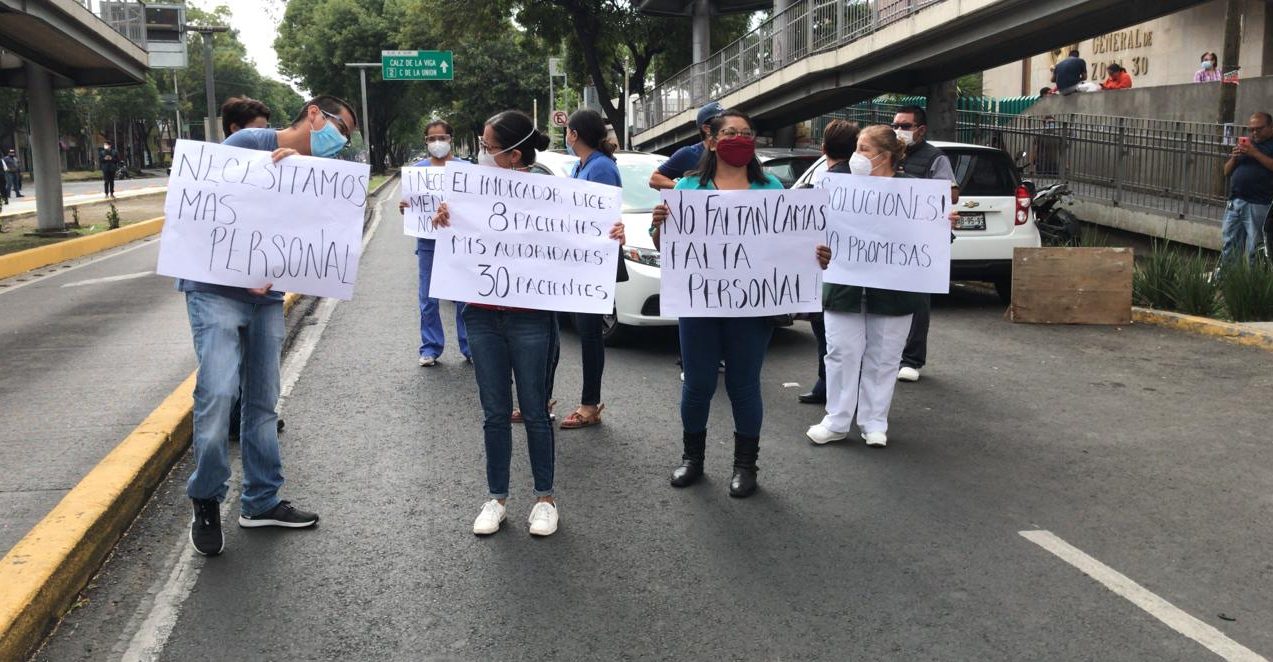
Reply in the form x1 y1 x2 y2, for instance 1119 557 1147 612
429 162 622 313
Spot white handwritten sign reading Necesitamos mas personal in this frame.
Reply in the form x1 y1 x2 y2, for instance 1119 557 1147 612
157 140 369 299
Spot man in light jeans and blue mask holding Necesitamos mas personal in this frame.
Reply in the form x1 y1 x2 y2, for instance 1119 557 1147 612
177 95 358 556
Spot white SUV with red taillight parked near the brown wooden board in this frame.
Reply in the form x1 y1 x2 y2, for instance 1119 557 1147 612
796 141 1043 302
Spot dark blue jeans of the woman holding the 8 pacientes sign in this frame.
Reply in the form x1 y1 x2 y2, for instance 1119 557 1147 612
463 306 558 499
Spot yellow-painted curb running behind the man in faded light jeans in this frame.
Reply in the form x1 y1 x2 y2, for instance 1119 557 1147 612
0 293 300 659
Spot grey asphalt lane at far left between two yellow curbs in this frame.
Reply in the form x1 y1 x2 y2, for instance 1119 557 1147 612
0 238 195 554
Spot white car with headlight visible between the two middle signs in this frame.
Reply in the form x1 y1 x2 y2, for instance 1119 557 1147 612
531 151 676 344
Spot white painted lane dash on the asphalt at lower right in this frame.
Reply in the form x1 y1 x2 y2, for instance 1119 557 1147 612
1018 531 1268 662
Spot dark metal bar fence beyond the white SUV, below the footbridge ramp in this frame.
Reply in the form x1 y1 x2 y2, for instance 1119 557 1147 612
813 103 1235 223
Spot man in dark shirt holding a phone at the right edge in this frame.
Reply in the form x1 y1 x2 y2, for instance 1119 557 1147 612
1220 112 1273 266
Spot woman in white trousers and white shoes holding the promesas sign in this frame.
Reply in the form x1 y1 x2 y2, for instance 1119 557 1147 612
805 125 942 448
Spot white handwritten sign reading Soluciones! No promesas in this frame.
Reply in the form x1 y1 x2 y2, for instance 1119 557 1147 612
817 172 951 294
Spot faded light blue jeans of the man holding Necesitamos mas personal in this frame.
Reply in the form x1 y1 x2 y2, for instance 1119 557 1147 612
186 292 284 516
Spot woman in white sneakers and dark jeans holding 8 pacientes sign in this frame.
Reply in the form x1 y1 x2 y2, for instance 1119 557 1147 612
433 111 622 536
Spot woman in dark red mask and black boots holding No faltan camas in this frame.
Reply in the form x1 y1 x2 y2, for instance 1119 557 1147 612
651 109 831 498
